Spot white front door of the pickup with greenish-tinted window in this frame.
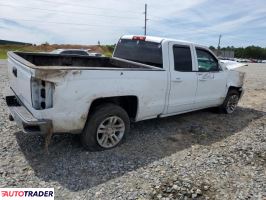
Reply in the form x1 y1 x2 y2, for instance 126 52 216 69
195 47 226 108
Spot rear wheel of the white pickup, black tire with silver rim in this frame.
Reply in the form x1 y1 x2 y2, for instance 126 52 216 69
81 104 130 151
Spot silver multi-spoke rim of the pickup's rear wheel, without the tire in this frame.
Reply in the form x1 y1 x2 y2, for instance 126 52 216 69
97 116 125 148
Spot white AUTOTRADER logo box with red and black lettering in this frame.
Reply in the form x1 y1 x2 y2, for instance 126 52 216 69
0 188 54 200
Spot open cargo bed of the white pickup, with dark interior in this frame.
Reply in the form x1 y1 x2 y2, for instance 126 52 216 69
8 52 160 70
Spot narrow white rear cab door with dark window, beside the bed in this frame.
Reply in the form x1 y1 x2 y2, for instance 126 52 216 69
167 42 197 114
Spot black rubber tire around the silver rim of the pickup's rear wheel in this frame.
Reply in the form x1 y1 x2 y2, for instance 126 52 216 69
81 103 130 151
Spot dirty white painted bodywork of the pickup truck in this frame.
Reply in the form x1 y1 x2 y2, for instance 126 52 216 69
5 36 244 133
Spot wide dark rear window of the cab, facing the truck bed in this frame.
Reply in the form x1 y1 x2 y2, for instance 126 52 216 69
114 39 163 68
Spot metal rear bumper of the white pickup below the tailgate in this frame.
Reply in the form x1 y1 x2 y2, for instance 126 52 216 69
6 96 52 134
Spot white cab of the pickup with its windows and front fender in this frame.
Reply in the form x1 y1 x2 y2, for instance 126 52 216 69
113 35 244 117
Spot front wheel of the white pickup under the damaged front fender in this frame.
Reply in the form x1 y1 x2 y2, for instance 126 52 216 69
220 89 240 114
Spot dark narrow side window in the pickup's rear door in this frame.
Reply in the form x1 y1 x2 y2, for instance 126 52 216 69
173 45 192 72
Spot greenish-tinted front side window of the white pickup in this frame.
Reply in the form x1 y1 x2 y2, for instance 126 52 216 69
196 48 219 72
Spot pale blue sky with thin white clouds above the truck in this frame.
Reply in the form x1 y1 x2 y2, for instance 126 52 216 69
0 0 266 47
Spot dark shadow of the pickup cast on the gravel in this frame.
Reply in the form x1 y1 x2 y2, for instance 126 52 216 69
16 107 265 191
